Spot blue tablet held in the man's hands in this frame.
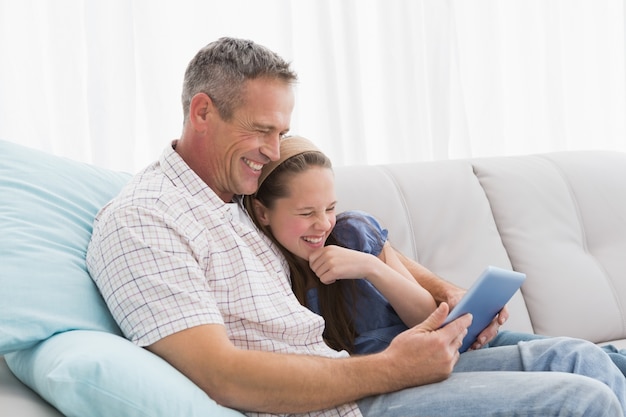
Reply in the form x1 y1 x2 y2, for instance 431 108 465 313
443 266 526 353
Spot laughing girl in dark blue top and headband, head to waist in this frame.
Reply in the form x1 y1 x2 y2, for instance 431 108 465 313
245 137 436 353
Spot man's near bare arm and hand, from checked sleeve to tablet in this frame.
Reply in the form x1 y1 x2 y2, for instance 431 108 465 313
148 304 471 413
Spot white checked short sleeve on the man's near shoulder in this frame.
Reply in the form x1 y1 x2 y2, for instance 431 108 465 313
88 201 223 346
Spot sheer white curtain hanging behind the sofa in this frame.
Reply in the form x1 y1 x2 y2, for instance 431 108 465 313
0 0 626 171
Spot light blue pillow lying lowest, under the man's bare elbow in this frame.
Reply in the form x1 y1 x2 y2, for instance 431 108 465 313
6 330 243 417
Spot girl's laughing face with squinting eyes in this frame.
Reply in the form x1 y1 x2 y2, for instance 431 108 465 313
254 166 336 260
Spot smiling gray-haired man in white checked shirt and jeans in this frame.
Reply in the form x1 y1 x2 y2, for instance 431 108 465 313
87 38 625 416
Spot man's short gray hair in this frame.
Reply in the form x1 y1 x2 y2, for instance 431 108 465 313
181 37 298 122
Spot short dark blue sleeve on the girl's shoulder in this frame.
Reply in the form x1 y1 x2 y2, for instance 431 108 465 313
333 210 389 256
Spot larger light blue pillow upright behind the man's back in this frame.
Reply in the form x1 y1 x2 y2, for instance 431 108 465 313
0 141 130 354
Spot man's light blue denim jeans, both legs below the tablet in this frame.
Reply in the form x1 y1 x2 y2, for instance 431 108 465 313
359 338 626 417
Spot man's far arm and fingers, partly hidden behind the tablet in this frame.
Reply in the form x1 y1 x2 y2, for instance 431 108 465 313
395 249 509 349
